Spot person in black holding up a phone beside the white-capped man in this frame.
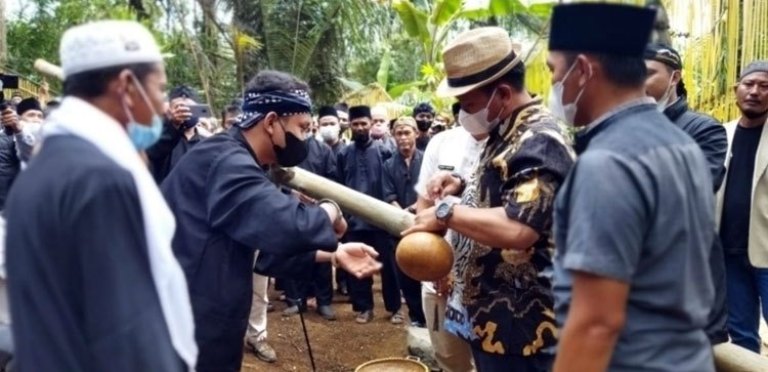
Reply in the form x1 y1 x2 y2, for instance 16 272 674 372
146 85 203 183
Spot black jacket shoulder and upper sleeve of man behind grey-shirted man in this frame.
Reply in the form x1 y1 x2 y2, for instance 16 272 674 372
664 97 728 192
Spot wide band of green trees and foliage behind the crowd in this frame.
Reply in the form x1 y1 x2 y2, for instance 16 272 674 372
1 0 553 113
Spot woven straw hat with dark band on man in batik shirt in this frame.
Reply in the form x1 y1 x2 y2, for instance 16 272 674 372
437 27 521 97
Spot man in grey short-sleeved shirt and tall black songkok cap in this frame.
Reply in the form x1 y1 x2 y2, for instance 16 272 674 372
547 3 715 372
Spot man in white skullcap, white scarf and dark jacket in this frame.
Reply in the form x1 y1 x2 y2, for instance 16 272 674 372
6 21 198 372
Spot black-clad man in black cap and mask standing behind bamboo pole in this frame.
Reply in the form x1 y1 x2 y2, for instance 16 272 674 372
336 106 404 324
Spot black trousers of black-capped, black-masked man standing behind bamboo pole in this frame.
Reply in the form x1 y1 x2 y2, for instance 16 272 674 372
346 230 401 313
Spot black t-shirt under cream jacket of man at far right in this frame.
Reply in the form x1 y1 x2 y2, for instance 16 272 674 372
720 126 763 253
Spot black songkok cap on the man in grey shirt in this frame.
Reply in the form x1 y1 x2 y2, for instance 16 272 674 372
549 3 656 57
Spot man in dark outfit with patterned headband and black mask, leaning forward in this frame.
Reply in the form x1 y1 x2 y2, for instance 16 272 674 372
161 71 379 372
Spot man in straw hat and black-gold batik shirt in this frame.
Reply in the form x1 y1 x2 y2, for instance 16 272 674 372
405 27 573 372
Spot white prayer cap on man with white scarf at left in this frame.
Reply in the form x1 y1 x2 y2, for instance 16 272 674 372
59 20 163 79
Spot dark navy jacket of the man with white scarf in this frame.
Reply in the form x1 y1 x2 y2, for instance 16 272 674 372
6 135 183 372
